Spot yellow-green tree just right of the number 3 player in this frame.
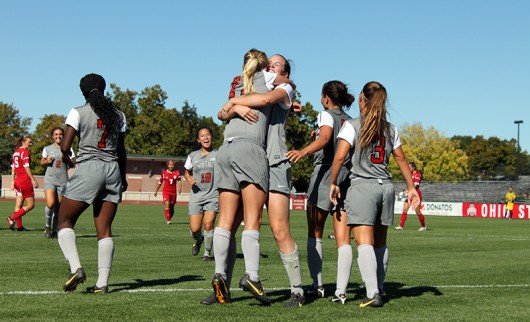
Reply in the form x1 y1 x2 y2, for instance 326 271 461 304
389 123 468 182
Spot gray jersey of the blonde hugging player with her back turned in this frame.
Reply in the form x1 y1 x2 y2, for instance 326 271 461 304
224 72 272 147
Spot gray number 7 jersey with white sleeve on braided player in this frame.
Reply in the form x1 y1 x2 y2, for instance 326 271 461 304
65 104 127 163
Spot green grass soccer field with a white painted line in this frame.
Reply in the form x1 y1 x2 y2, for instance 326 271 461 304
0 201 530 321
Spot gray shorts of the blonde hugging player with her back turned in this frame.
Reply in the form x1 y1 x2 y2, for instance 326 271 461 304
214 139 269 192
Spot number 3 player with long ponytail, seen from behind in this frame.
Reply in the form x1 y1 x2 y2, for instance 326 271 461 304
330 82 419 307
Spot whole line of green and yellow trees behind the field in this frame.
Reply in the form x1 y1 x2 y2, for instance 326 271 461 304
0 84 530 191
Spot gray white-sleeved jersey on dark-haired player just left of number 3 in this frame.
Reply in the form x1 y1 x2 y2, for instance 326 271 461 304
313 108 351 166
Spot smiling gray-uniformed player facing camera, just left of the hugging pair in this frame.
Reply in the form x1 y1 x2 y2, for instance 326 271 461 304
184 127 219 261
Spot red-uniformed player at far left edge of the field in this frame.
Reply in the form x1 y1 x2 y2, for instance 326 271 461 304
7 135 39 231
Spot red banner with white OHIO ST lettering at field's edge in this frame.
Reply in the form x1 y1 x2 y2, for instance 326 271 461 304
462 202 530 219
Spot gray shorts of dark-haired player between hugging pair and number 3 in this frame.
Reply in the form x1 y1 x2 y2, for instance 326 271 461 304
307 165 350 211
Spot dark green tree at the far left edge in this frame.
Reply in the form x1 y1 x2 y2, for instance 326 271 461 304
0 101 32 173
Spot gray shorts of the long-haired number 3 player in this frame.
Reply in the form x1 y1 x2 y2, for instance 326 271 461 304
344 179 396 226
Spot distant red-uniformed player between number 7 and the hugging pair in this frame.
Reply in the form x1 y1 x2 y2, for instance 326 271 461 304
155 160 182 225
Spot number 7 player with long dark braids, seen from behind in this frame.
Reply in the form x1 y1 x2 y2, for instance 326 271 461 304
58 74 127 293
